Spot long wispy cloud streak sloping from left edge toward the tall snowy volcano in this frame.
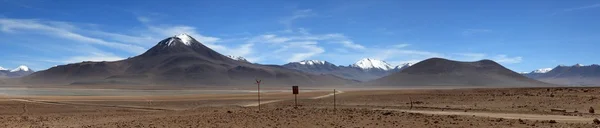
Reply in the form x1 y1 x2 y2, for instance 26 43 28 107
0 18 145 53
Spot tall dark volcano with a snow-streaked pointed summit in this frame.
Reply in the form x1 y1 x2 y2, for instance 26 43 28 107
22 34 355 86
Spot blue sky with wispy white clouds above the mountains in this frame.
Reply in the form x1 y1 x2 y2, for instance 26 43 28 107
0 0 600 72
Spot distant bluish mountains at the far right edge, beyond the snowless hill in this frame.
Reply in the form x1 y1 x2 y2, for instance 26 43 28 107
522 64 600 86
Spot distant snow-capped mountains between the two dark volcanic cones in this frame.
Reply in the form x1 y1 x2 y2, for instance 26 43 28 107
283 58 412 81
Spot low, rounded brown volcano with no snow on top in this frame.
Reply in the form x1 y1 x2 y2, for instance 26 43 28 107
365 58 555 87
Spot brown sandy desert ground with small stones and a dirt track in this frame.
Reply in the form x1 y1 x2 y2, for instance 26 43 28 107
0 88 600 128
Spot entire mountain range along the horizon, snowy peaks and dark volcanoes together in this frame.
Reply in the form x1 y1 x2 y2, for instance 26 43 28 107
9 34 600 86
